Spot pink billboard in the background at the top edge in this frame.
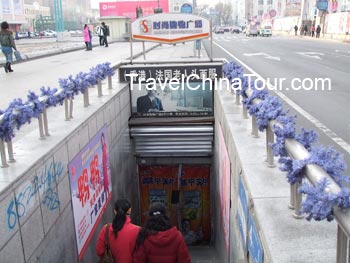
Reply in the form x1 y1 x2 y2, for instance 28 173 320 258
100 0 169 19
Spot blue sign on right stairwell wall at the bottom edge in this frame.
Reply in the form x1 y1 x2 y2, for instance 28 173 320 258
248 215 264 263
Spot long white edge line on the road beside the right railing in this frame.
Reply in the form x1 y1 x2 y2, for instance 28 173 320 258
214 42 350 153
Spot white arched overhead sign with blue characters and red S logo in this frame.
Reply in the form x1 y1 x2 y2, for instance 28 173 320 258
131 14 210 43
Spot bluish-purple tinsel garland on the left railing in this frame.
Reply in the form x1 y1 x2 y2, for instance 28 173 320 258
0 62 114 142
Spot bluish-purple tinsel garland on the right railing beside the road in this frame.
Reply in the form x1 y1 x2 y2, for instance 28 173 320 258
223 61 350 221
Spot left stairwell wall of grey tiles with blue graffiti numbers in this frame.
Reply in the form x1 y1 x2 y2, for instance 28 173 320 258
0 81 137 263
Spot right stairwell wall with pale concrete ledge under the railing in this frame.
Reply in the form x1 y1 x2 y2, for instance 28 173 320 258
212 91 337 263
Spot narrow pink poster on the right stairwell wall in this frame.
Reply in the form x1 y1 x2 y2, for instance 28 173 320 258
219 124 231 255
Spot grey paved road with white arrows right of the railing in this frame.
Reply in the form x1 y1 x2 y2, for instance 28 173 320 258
205 33 350 169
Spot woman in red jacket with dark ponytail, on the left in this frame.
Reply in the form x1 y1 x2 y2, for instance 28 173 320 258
96 199 140 263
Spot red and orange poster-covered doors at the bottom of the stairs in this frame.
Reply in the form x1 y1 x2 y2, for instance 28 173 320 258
138 164 210 245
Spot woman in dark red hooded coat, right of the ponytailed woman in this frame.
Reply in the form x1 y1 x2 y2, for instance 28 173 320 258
133 203 191 263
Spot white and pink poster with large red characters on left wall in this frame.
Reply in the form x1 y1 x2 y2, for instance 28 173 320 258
68 126 112 260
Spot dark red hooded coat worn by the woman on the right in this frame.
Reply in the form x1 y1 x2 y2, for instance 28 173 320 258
133 227 191 263
